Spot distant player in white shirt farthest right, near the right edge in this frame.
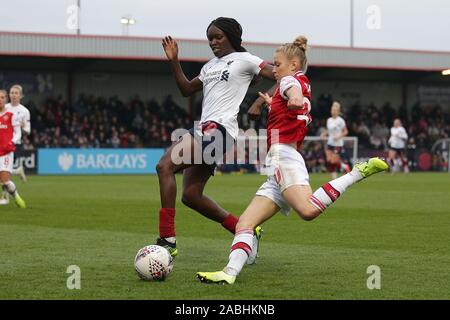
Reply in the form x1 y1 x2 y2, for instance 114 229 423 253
388 119 409 173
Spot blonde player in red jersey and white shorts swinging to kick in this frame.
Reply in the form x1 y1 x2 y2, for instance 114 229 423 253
197 37 388 284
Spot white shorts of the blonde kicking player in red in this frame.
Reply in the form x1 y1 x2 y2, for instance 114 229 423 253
256 143 309 215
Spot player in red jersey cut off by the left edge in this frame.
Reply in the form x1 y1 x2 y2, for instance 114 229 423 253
0 90 26 209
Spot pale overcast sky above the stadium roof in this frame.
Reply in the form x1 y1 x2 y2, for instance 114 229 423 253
0 0 450 52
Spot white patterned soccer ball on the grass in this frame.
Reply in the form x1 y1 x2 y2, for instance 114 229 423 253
134 245 173 281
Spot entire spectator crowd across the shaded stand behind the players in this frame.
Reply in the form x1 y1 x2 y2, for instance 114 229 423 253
24 94 450 160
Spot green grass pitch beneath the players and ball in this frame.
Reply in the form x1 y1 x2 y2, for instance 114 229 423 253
0 173 450 299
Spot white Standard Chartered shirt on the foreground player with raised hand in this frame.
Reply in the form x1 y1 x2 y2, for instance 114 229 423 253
198 52 264 139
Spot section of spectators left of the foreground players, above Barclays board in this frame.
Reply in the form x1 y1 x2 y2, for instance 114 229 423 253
24 95 192 150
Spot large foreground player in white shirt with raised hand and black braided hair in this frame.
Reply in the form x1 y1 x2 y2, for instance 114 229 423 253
156 17 274 256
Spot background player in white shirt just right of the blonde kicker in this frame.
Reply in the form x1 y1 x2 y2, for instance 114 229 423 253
322 101 350 179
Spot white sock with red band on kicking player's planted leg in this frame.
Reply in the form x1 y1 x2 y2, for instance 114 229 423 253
224 229 253 276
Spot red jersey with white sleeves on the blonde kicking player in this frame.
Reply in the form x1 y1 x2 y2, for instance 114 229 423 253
267 71 312 150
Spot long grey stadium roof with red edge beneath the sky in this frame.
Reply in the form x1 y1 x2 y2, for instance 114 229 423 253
0 32 450 71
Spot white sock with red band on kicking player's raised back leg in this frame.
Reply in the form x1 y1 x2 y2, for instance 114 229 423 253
309 170 363 212
